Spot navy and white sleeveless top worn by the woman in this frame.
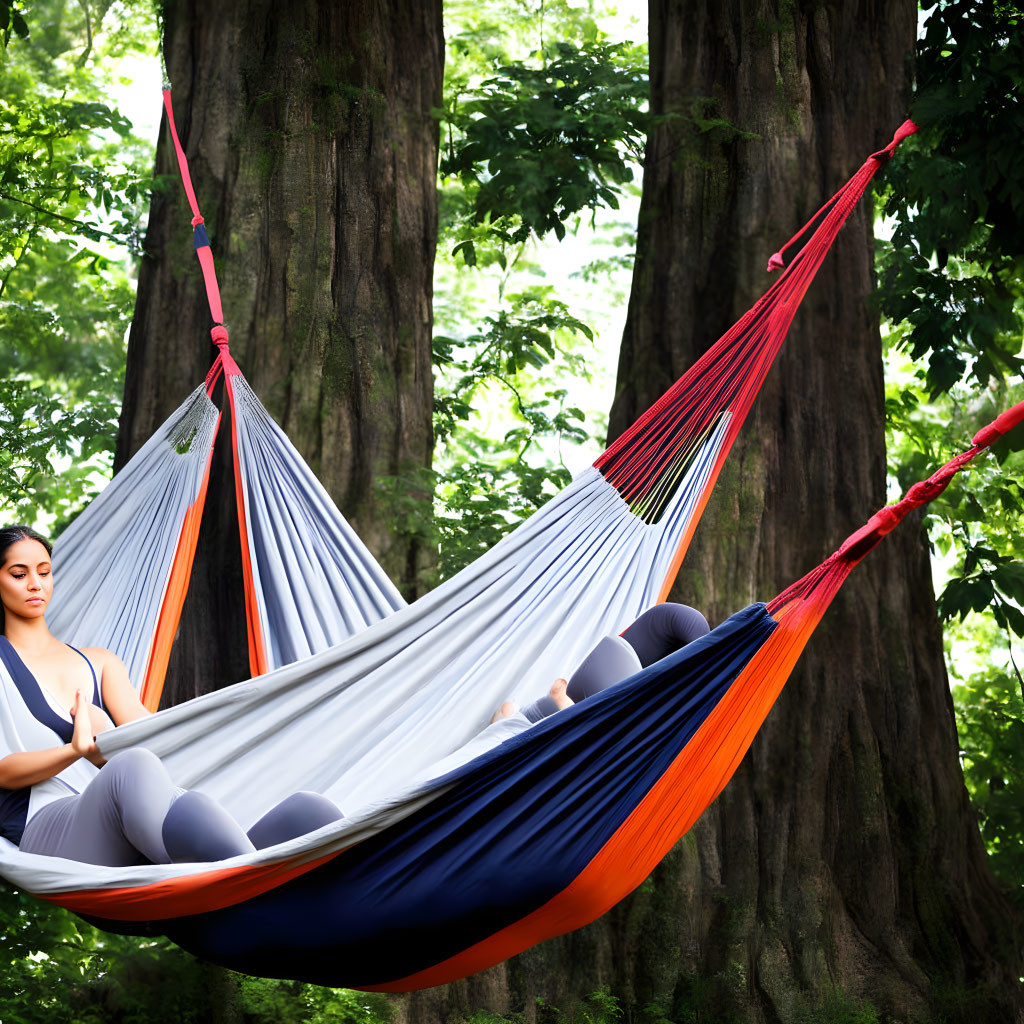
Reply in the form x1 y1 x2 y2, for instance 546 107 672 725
0 635 105 843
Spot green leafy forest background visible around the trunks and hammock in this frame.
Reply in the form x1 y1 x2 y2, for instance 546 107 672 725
0 0 1024 1024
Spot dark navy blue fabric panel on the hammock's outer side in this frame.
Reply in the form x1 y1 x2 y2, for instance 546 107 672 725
167 604 776 989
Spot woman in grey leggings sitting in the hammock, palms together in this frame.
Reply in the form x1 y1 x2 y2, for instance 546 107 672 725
0 526 342 866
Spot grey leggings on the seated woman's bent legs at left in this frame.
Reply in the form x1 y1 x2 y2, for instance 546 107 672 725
20 748 342 867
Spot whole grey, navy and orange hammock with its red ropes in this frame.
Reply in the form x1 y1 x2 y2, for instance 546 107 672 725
0 101 999 990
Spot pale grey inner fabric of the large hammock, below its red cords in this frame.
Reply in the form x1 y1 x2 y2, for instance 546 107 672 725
0 387 728 894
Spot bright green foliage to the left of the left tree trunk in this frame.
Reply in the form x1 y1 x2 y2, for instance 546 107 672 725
0 0 153 526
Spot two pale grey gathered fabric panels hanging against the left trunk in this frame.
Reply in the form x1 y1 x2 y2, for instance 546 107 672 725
47 374 406 688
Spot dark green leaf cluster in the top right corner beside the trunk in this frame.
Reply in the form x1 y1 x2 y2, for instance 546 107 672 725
879 0 1024 397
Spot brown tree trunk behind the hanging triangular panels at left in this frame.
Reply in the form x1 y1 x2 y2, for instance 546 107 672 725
117 0 443 705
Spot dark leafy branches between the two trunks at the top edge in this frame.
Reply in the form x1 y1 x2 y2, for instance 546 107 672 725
438 0 648 252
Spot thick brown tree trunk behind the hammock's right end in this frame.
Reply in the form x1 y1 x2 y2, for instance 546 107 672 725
395 0 1022 1024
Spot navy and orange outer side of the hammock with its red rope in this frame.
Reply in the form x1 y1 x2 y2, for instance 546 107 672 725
28 395 1024 991
